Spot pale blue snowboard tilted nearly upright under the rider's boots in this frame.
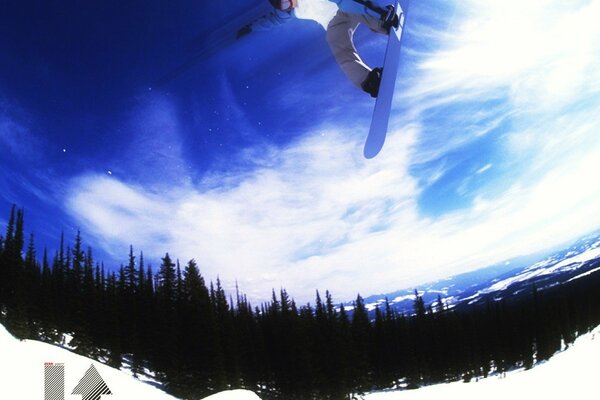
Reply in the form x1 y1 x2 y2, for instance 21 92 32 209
364 1 404 158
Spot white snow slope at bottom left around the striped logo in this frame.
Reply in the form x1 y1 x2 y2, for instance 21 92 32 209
0 325 260 400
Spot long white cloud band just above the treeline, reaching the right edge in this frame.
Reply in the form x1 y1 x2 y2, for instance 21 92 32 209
68 119 600 299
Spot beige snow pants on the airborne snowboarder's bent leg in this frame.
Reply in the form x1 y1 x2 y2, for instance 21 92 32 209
327 10 387 88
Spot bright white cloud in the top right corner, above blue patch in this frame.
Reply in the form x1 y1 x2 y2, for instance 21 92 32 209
411 0 600 109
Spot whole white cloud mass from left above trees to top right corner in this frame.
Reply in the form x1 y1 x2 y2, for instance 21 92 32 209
67 0 600 300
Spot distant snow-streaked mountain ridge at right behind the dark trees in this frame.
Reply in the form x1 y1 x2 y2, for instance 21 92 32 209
352 231 600 314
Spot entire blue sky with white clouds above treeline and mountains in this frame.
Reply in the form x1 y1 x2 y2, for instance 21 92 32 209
0 0 600 301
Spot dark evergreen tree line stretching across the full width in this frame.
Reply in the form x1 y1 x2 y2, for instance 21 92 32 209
0 207 600 399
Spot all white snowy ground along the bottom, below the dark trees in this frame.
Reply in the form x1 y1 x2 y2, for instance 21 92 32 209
0 325 600 400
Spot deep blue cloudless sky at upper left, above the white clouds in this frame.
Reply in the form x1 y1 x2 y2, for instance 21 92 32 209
0 0 376 260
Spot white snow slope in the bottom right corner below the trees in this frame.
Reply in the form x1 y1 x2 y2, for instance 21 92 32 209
365 327 600 400
